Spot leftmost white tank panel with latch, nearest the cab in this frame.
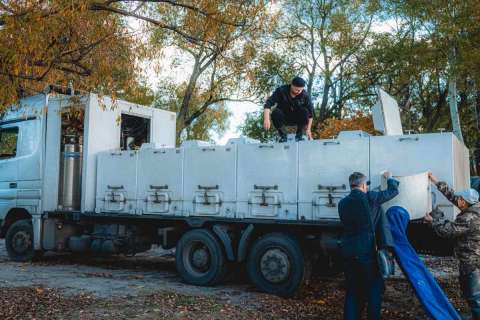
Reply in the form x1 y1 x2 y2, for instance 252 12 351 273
96 151 138 214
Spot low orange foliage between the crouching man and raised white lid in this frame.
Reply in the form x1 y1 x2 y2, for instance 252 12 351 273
314 113 375 139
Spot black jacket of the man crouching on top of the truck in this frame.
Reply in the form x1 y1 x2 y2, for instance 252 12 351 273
264 84 314 118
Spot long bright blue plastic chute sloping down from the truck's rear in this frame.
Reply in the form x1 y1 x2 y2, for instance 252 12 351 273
387 207 461 320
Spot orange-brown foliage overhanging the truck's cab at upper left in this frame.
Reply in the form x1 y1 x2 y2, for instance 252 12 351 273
0 0 137 106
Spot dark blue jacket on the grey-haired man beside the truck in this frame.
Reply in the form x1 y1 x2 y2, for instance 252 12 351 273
338 179 399 257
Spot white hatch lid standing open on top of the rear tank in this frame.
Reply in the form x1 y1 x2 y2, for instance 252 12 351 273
372 88 403 136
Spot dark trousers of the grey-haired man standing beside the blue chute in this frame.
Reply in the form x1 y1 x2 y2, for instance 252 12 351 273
343 257 385 320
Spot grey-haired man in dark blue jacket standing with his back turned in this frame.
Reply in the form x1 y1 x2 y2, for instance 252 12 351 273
338 172 399 320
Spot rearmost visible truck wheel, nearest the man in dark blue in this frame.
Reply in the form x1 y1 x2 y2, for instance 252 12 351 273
247 233 309 297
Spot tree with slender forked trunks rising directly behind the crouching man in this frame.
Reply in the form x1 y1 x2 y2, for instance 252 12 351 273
251 0 378 122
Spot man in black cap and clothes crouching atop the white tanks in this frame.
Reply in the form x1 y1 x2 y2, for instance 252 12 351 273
263 77 313 142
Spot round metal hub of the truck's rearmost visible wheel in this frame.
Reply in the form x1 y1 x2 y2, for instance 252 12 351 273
260 248 290 283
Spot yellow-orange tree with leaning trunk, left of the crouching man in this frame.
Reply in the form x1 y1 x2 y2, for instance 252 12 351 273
146 0 266 141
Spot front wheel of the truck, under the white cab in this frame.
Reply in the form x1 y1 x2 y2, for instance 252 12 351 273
5 220 37 262
